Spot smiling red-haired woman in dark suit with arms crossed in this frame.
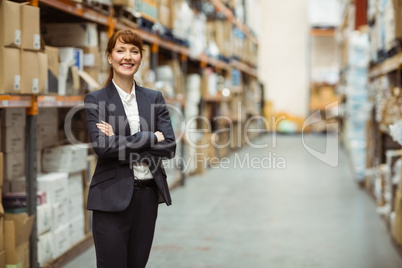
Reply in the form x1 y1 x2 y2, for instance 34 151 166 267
85 30 176 268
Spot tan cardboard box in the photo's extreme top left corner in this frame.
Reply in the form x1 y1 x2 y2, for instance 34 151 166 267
0 1 21 47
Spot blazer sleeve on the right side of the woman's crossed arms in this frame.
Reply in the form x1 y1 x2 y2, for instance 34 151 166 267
145 92 176 159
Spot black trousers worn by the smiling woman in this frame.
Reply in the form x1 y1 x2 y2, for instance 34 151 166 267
92 187 159 268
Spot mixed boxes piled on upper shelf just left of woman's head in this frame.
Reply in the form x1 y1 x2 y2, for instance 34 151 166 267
43 23 102 95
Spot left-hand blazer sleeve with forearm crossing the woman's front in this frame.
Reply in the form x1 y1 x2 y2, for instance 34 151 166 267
84 94 158 160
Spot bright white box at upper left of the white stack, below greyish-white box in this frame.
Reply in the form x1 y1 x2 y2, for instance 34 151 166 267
37 172 68 204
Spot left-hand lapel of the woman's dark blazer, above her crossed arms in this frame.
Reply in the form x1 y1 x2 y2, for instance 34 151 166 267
106 81 130 136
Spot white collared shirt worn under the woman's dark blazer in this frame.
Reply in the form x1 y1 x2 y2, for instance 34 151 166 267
112 80 153 180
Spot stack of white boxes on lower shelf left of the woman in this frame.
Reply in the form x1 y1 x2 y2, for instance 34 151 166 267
38 145 88 264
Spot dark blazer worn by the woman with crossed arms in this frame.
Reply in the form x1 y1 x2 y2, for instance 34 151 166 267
84 82 176 211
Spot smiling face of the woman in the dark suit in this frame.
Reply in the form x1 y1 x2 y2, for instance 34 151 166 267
108 40 141 80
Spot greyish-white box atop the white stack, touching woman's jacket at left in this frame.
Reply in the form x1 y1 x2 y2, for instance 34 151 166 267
43 145 88 173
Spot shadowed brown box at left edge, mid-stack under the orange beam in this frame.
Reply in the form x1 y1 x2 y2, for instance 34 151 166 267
1 127 25 153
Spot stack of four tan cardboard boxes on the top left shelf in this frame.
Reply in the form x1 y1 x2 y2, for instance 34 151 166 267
0 1 47 94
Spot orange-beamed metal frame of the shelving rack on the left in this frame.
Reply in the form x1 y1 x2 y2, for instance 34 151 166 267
0 0 258 268
